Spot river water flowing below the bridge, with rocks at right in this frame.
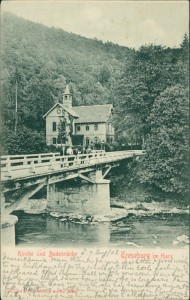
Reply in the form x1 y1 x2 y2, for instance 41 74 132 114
11 200 189 249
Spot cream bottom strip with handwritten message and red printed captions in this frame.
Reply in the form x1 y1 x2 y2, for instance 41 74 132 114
1 248 189 300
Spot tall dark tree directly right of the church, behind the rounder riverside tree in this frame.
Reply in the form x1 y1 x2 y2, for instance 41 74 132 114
114 45 184 146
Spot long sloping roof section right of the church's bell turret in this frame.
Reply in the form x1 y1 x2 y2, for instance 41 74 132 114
72 104 113 123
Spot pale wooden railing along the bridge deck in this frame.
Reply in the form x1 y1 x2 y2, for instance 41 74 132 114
1 150 143 181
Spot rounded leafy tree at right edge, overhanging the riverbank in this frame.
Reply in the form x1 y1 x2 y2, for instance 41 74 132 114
139 84 189 195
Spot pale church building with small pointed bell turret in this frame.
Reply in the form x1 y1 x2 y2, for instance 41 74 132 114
43 85 114 149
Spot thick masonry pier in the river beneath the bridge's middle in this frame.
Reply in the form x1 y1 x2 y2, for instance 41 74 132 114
47 170 110 215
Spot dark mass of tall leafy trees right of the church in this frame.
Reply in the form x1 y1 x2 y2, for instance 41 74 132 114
115 35 189 195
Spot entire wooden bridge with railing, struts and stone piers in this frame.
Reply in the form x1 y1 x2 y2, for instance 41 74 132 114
1 150 144 246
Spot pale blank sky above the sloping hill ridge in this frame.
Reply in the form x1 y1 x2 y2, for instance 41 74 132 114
1 0 189 49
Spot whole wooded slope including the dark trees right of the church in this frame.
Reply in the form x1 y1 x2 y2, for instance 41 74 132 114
1 14 189 199
